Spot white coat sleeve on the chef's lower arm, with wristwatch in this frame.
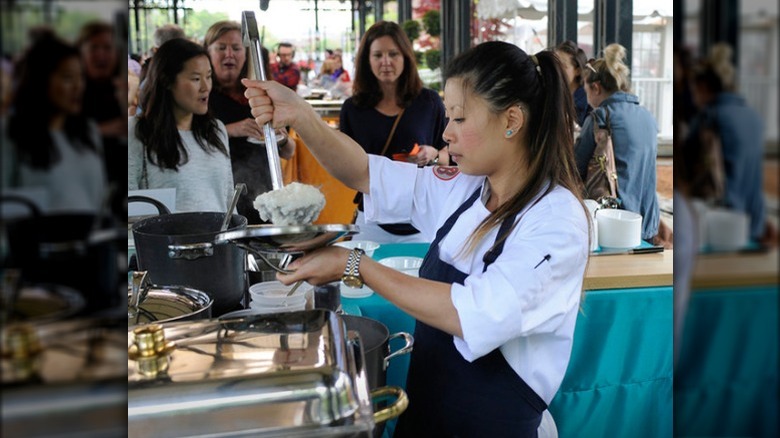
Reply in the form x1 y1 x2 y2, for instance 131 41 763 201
451 196 588 361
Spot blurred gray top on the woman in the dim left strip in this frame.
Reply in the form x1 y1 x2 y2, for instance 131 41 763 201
0 120 108 213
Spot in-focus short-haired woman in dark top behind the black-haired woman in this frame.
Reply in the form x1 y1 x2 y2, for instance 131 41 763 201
203 21 295 224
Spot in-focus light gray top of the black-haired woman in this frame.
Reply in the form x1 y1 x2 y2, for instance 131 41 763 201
127 117 233 213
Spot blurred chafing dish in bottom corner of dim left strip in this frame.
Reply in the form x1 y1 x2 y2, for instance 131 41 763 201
0 317 127 438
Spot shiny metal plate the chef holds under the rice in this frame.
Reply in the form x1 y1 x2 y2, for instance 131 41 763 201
214 224 359 254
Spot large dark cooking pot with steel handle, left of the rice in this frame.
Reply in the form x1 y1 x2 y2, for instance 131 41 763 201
133 212 247 316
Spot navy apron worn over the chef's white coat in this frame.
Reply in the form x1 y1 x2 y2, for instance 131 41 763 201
394 188 547 438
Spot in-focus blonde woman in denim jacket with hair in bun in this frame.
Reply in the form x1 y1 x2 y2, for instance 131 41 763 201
574 44 672 248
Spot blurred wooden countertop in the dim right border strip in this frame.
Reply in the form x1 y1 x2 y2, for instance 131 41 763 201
692 248 779 290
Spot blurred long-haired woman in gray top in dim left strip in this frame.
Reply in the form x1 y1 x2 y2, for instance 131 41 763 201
0 34 107 213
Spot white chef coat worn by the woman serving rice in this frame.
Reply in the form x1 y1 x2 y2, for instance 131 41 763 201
364 155 589 404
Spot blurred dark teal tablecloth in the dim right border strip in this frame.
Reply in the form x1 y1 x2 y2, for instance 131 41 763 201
674 285 780 437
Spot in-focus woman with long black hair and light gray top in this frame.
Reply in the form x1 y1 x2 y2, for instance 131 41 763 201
127 39 233 212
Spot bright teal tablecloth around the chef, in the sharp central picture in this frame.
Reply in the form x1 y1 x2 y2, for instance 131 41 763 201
342 244 672 438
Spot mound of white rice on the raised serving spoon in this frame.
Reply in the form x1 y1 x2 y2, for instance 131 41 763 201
254 182 325 225
